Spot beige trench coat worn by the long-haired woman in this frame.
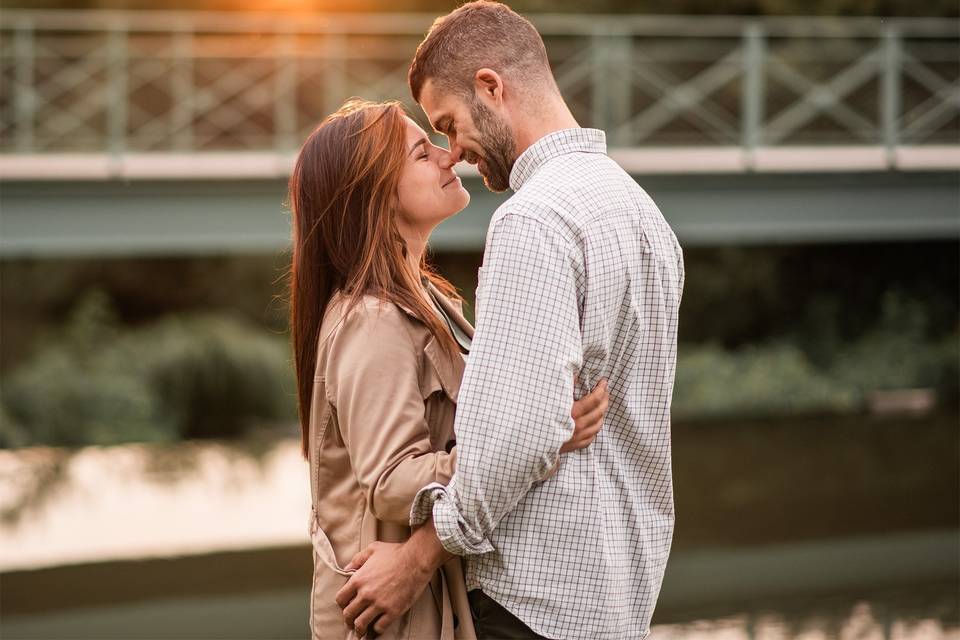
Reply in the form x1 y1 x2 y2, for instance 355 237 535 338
309 285 476 640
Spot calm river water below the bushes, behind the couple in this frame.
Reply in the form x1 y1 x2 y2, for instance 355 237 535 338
0 420 960 640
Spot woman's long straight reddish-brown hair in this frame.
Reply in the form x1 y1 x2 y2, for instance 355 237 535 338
289 99 457 457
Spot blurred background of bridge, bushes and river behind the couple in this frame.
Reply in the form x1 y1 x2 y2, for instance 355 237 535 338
0 0 960 640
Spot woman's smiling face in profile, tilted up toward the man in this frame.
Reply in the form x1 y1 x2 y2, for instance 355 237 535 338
398 118 470 240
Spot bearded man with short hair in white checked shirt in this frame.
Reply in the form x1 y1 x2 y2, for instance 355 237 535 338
337 0 684 640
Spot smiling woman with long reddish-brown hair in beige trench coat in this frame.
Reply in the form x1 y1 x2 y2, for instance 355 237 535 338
290 100 606 639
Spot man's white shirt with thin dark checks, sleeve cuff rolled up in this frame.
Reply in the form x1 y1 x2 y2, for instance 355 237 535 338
411 129 684 640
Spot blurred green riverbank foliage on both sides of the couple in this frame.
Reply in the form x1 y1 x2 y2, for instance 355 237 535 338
0 282 960 447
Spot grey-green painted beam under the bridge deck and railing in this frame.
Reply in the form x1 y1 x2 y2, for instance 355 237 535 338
0 172 960 259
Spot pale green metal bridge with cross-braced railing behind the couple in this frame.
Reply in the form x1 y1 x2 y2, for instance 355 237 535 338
0 10 960 259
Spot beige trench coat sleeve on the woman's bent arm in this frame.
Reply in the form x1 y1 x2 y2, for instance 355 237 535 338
326 301 456 524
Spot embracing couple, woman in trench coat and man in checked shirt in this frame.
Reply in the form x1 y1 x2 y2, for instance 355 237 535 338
290 0 684 640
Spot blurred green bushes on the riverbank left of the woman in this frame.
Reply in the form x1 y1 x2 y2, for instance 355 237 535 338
0 292 293 446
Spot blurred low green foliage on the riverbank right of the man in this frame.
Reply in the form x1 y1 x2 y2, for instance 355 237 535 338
673 290 960 417
